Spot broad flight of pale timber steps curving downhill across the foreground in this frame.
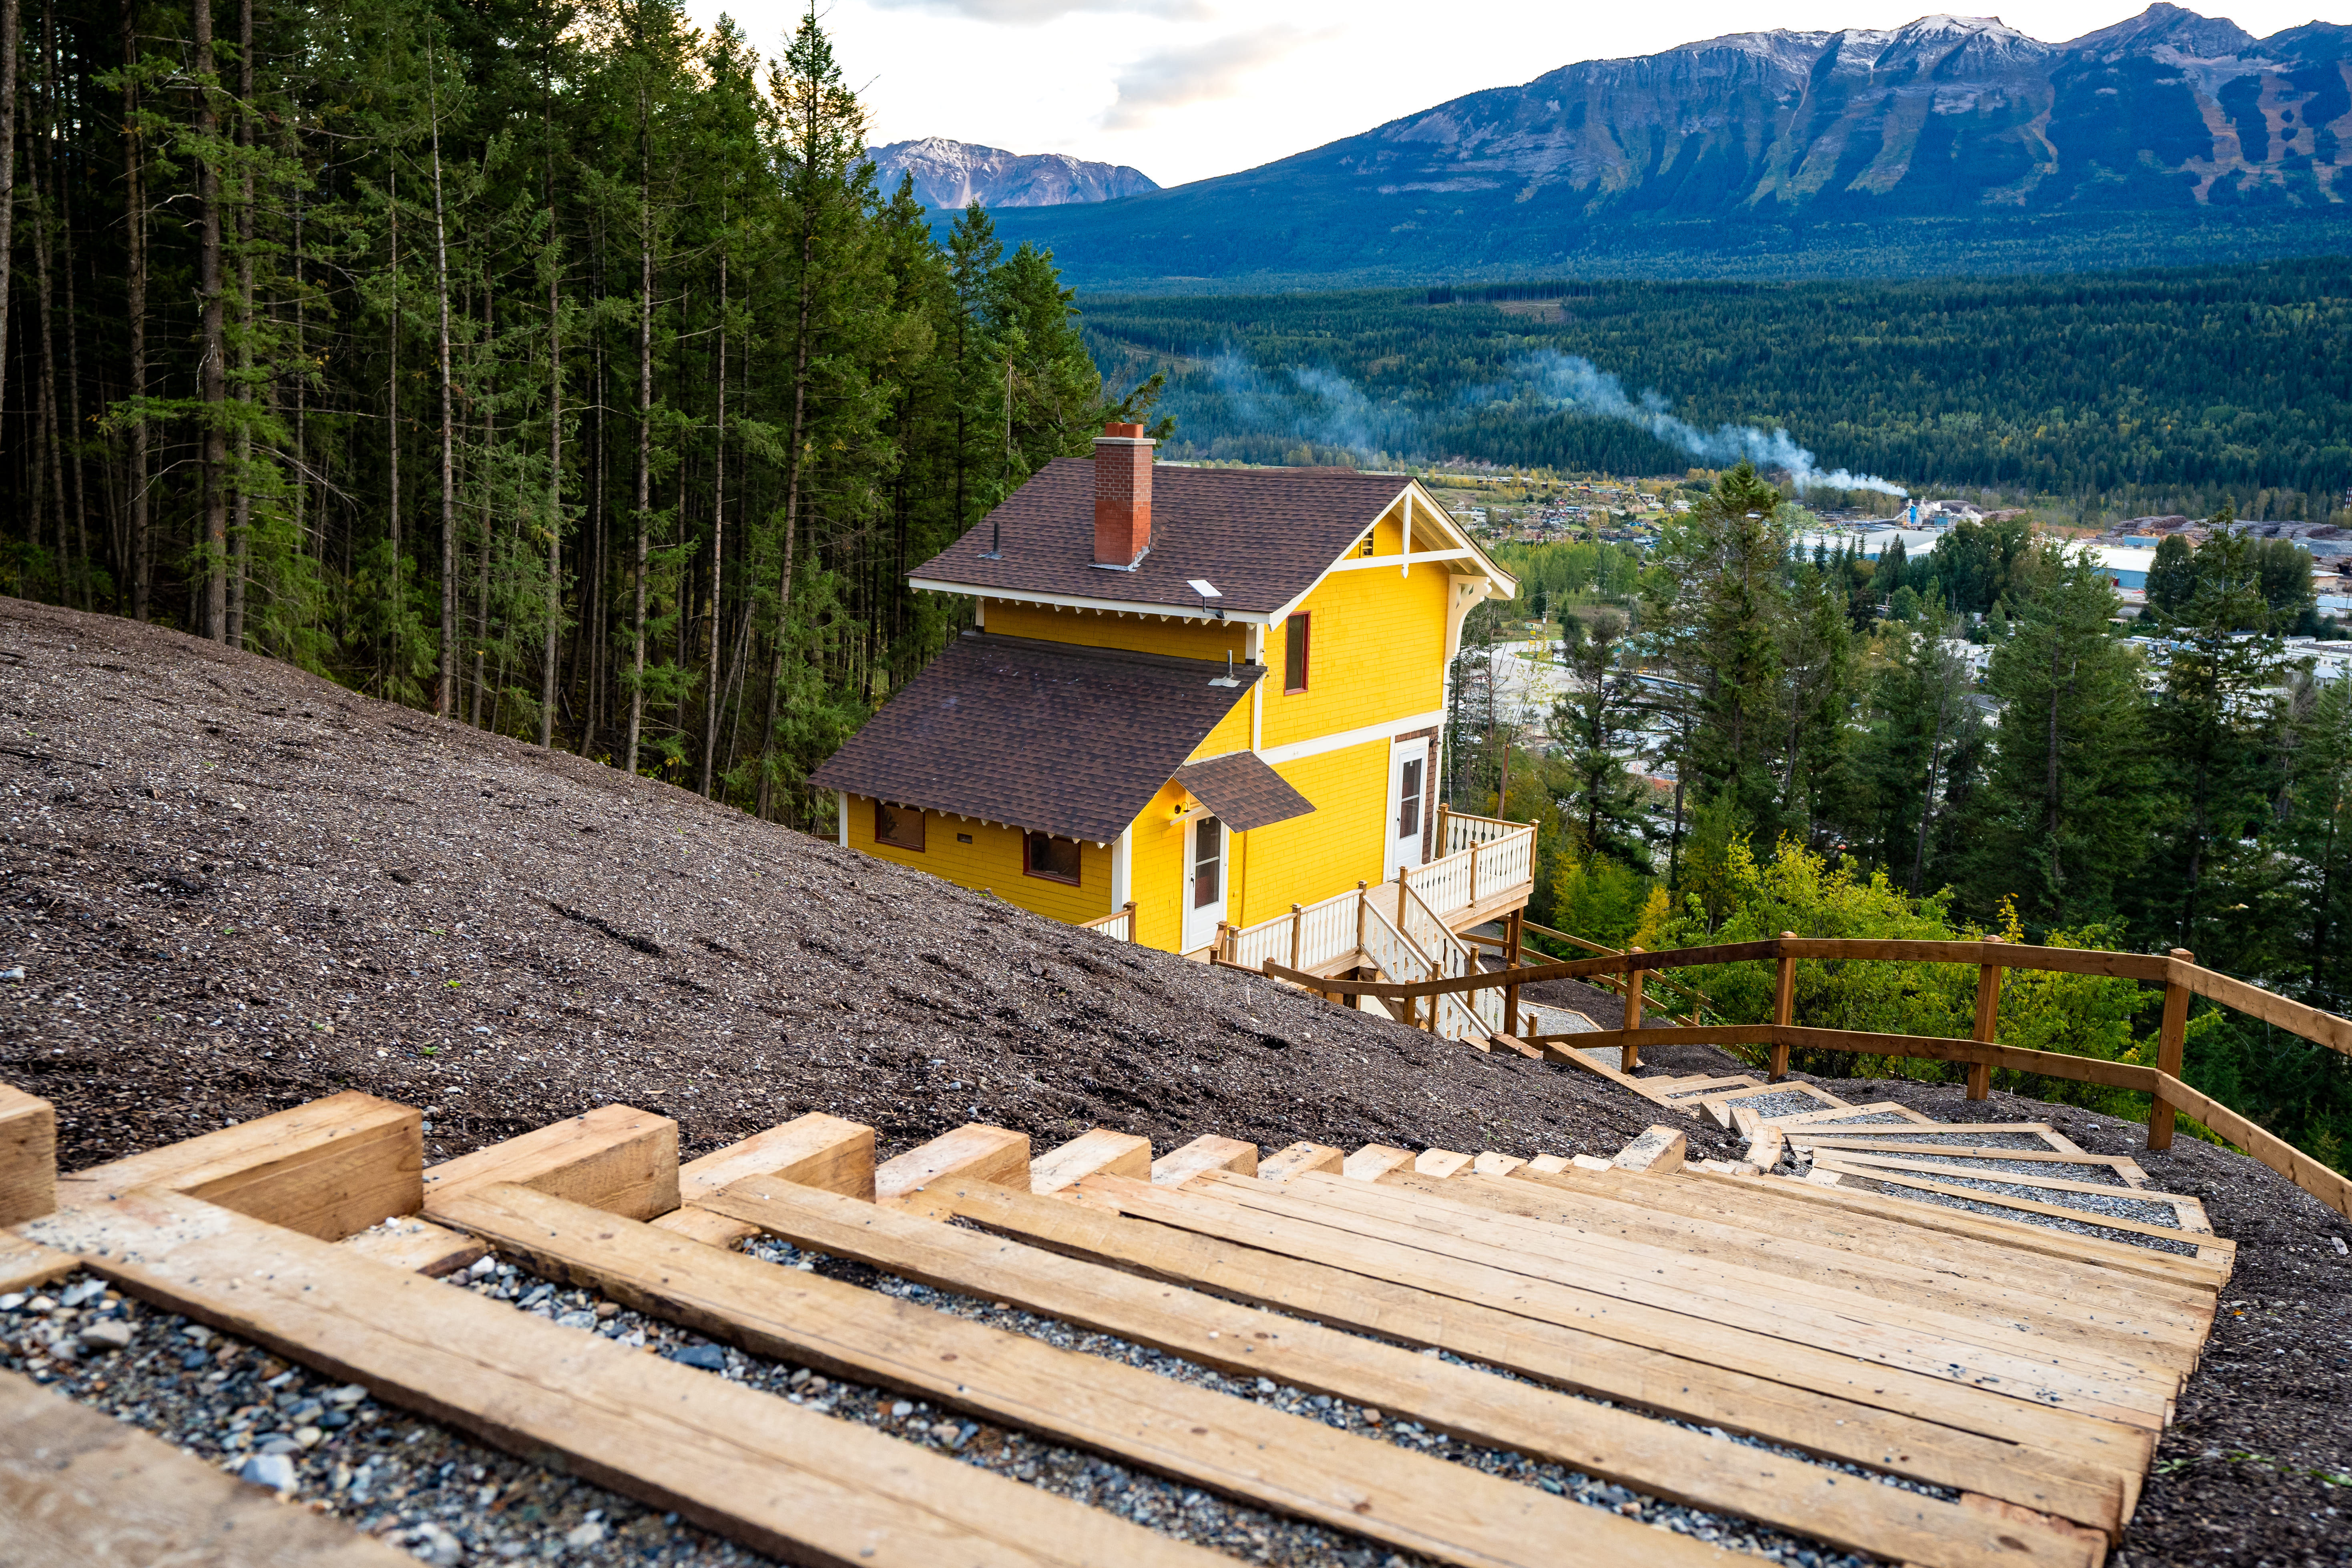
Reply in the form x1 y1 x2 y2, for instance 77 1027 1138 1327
0 1081 2230 1568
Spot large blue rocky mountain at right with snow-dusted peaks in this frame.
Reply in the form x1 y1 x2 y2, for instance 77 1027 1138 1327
1000 2 2352 289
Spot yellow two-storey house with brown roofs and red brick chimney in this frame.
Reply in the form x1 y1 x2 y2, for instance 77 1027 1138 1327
811 426 1534 1032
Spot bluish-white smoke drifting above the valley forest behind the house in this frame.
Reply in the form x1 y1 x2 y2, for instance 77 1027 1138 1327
1209 348 1908 496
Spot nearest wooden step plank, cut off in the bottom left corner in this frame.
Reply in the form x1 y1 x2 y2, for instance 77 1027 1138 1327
0 1371 416 1568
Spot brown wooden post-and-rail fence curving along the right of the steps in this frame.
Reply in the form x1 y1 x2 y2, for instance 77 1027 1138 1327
1265 933 2352 1218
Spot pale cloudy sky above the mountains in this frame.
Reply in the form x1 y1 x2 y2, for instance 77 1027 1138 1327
687 0 2352 186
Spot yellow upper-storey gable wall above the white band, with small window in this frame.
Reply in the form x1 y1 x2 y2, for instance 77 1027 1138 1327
1261 564 1449 747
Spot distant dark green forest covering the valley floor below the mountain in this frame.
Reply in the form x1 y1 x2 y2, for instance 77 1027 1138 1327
1087 256 2352 522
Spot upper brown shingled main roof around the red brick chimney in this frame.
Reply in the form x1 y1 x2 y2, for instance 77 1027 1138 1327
908 458 1406 614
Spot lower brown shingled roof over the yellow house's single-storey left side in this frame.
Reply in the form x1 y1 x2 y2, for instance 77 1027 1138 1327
809 632 1265 844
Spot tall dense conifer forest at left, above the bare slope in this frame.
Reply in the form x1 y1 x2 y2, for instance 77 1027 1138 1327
0 0 1155 821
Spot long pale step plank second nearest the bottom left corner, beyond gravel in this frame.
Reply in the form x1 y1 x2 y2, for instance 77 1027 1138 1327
28 1190 1225 1568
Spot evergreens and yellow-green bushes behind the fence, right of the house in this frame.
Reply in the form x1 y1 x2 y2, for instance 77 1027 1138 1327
1456 466 2352 1164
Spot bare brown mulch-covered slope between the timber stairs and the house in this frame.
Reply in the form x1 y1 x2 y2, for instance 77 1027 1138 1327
0 600 1731 1168
